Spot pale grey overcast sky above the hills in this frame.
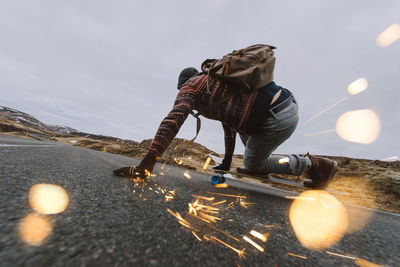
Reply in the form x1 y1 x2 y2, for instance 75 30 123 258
0 0 400 159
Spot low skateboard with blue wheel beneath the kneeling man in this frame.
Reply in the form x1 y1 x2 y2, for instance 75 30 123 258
211 170 348 195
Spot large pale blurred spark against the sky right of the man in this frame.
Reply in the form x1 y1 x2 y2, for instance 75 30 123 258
336 109 381 144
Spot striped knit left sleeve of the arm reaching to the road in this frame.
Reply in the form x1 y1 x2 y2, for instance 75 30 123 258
150 80 196 157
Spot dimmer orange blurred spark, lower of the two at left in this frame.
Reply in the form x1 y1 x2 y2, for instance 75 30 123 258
18 213 53 246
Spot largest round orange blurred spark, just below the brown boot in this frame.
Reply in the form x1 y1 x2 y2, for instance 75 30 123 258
289 190 348 250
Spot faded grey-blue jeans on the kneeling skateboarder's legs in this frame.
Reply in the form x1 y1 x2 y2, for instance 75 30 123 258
240 96 311 175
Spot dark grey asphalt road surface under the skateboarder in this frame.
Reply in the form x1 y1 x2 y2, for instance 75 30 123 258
0 135 400 266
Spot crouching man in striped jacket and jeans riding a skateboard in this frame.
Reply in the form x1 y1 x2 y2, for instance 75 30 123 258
114 68 337 189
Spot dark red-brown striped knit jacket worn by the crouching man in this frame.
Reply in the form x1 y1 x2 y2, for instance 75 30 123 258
150 74 257 156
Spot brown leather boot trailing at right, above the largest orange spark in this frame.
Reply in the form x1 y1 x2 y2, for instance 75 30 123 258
304 153 338 189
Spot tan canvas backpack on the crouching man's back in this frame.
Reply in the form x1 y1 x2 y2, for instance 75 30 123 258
201 44 276 91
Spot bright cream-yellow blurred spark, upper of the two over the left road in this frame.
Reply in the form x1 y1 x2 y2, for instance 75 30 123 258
29 184 69 214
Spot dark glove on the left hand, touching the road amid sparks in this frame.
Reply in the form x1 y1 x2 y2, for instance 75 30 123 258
113 151 157 179
